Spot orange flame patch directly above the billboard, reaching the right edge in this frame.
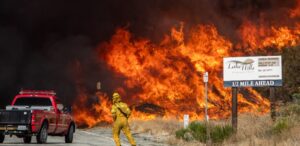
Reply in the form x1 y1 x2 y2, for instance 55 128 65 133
239 21 300 54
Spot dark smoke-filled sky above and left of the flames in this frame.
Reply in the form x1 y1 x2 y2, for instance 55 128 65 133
0 0 295 106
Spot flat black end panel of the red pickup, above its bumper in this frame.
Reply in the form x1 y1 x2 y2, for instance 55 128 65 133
0 110 31 125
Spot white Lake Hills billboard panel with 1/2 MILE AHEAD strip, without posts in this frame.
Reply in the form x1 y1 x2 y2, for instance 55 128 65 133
223 56 282 87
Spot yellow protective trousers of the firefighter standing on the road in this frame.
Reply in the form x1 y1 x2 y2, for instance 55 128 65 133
113 117 136 146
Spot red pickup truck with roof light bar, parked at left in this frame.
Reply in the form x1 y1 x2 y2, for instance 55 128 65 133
0 90 76 143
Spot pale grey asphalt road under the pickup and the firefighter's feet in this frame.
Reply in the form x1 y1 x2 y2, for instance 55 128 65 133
0 127 167 146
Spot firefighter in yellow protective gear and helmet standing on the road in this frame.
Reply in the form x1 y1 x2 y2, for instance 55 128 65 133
111 92 136 146
